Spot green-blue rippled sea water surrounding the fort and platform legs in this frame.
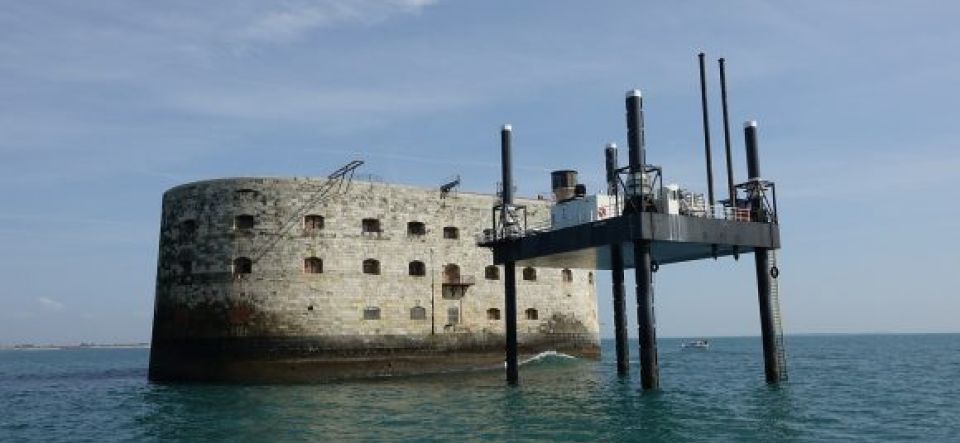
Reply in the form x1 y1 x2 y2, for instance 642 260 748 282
0 334 960 442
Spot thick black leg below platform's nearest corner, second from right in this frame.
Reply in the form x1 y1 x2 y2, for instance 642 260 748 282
633 240 660 390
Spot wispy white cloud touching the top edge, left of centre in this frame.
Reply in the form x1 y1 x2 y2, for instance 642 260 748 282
242 0 436 42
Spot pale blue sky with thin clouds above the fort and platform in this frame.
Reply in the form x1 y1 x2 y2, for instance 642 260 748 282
0 0 960 344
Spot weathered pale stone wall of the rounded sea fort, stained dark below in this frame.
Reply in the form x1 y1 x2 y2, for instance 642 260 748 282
151 178 599 378
